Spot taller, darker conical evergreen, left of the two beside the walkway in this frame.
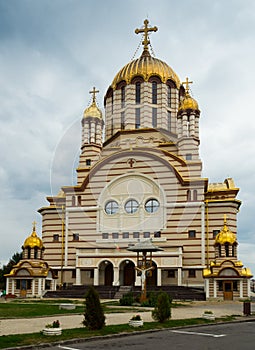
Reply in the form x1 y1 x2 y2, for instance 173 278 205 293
82 286 105 330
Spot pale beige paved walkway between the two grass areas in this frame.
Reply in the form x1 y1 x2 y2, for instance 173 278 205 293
0 301 251 336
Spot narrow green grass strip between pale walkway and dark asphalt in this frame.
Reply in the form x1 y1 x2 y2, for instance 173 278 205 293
0 317 237 349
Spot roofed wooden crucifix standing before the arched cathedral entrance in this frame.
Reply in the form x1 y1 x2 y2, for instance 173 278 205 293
127 239 163 302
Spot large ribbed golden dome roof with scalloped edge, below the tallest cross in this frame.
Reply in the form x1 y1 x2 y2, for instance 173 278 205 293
111 51 181 89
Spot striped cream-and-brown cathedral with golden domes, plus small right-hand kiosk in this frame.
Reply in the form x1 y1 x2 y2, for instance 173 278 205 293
5 20 252 299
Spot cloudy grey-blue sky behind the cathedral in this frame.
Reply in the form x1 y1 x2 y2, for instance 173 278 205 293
0 0 255 274
